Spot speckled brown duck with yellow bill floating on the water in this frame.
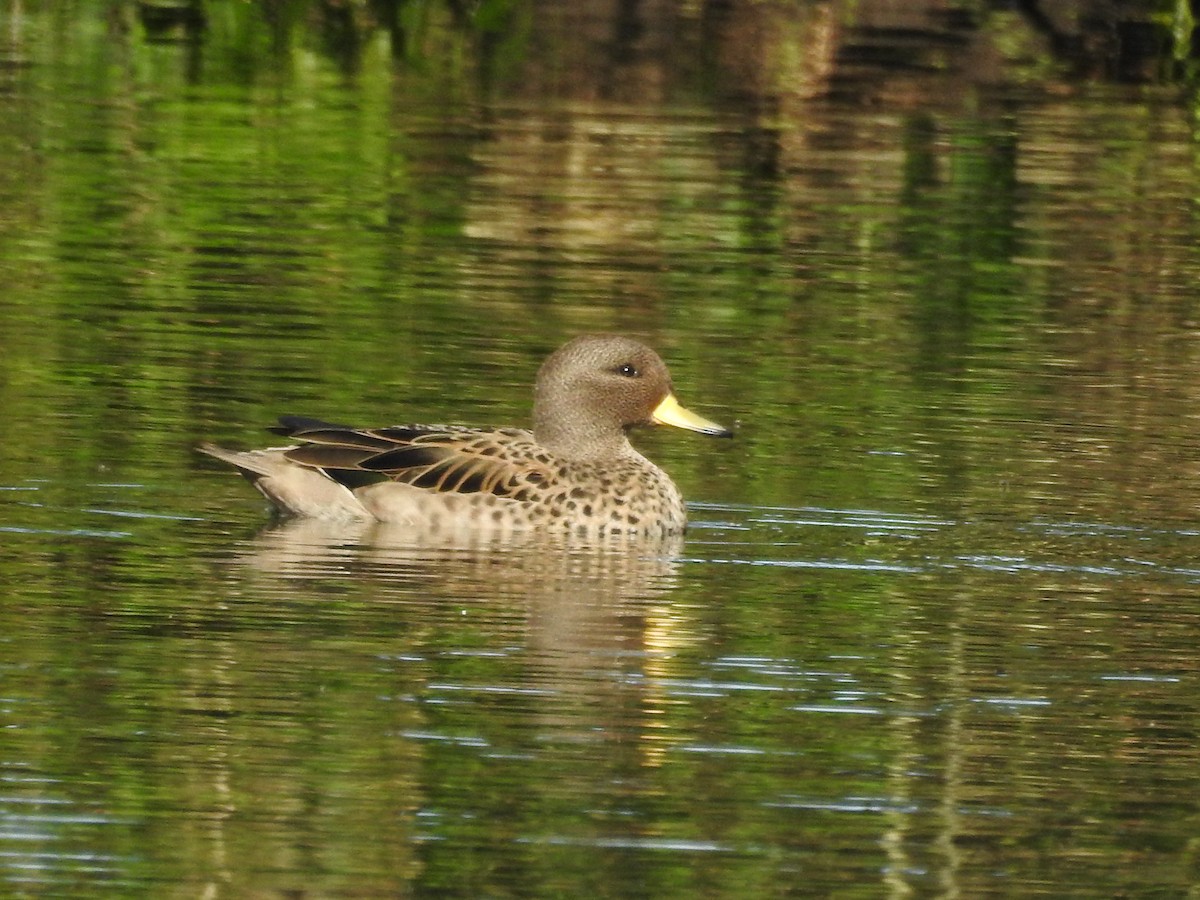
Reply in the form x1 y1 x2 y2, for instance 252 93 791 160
200 335 731 535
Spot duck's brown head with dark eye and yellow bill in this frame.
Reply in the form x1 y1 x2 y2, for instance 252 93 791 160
533 335 731 460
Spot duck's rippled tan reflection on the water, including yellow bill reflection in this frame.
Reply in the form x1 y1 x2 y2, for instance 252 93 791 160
231 520 689 764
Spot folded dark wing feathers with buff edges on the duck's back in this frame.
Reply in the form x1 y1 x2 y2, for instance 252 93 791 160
271 416 552 499
